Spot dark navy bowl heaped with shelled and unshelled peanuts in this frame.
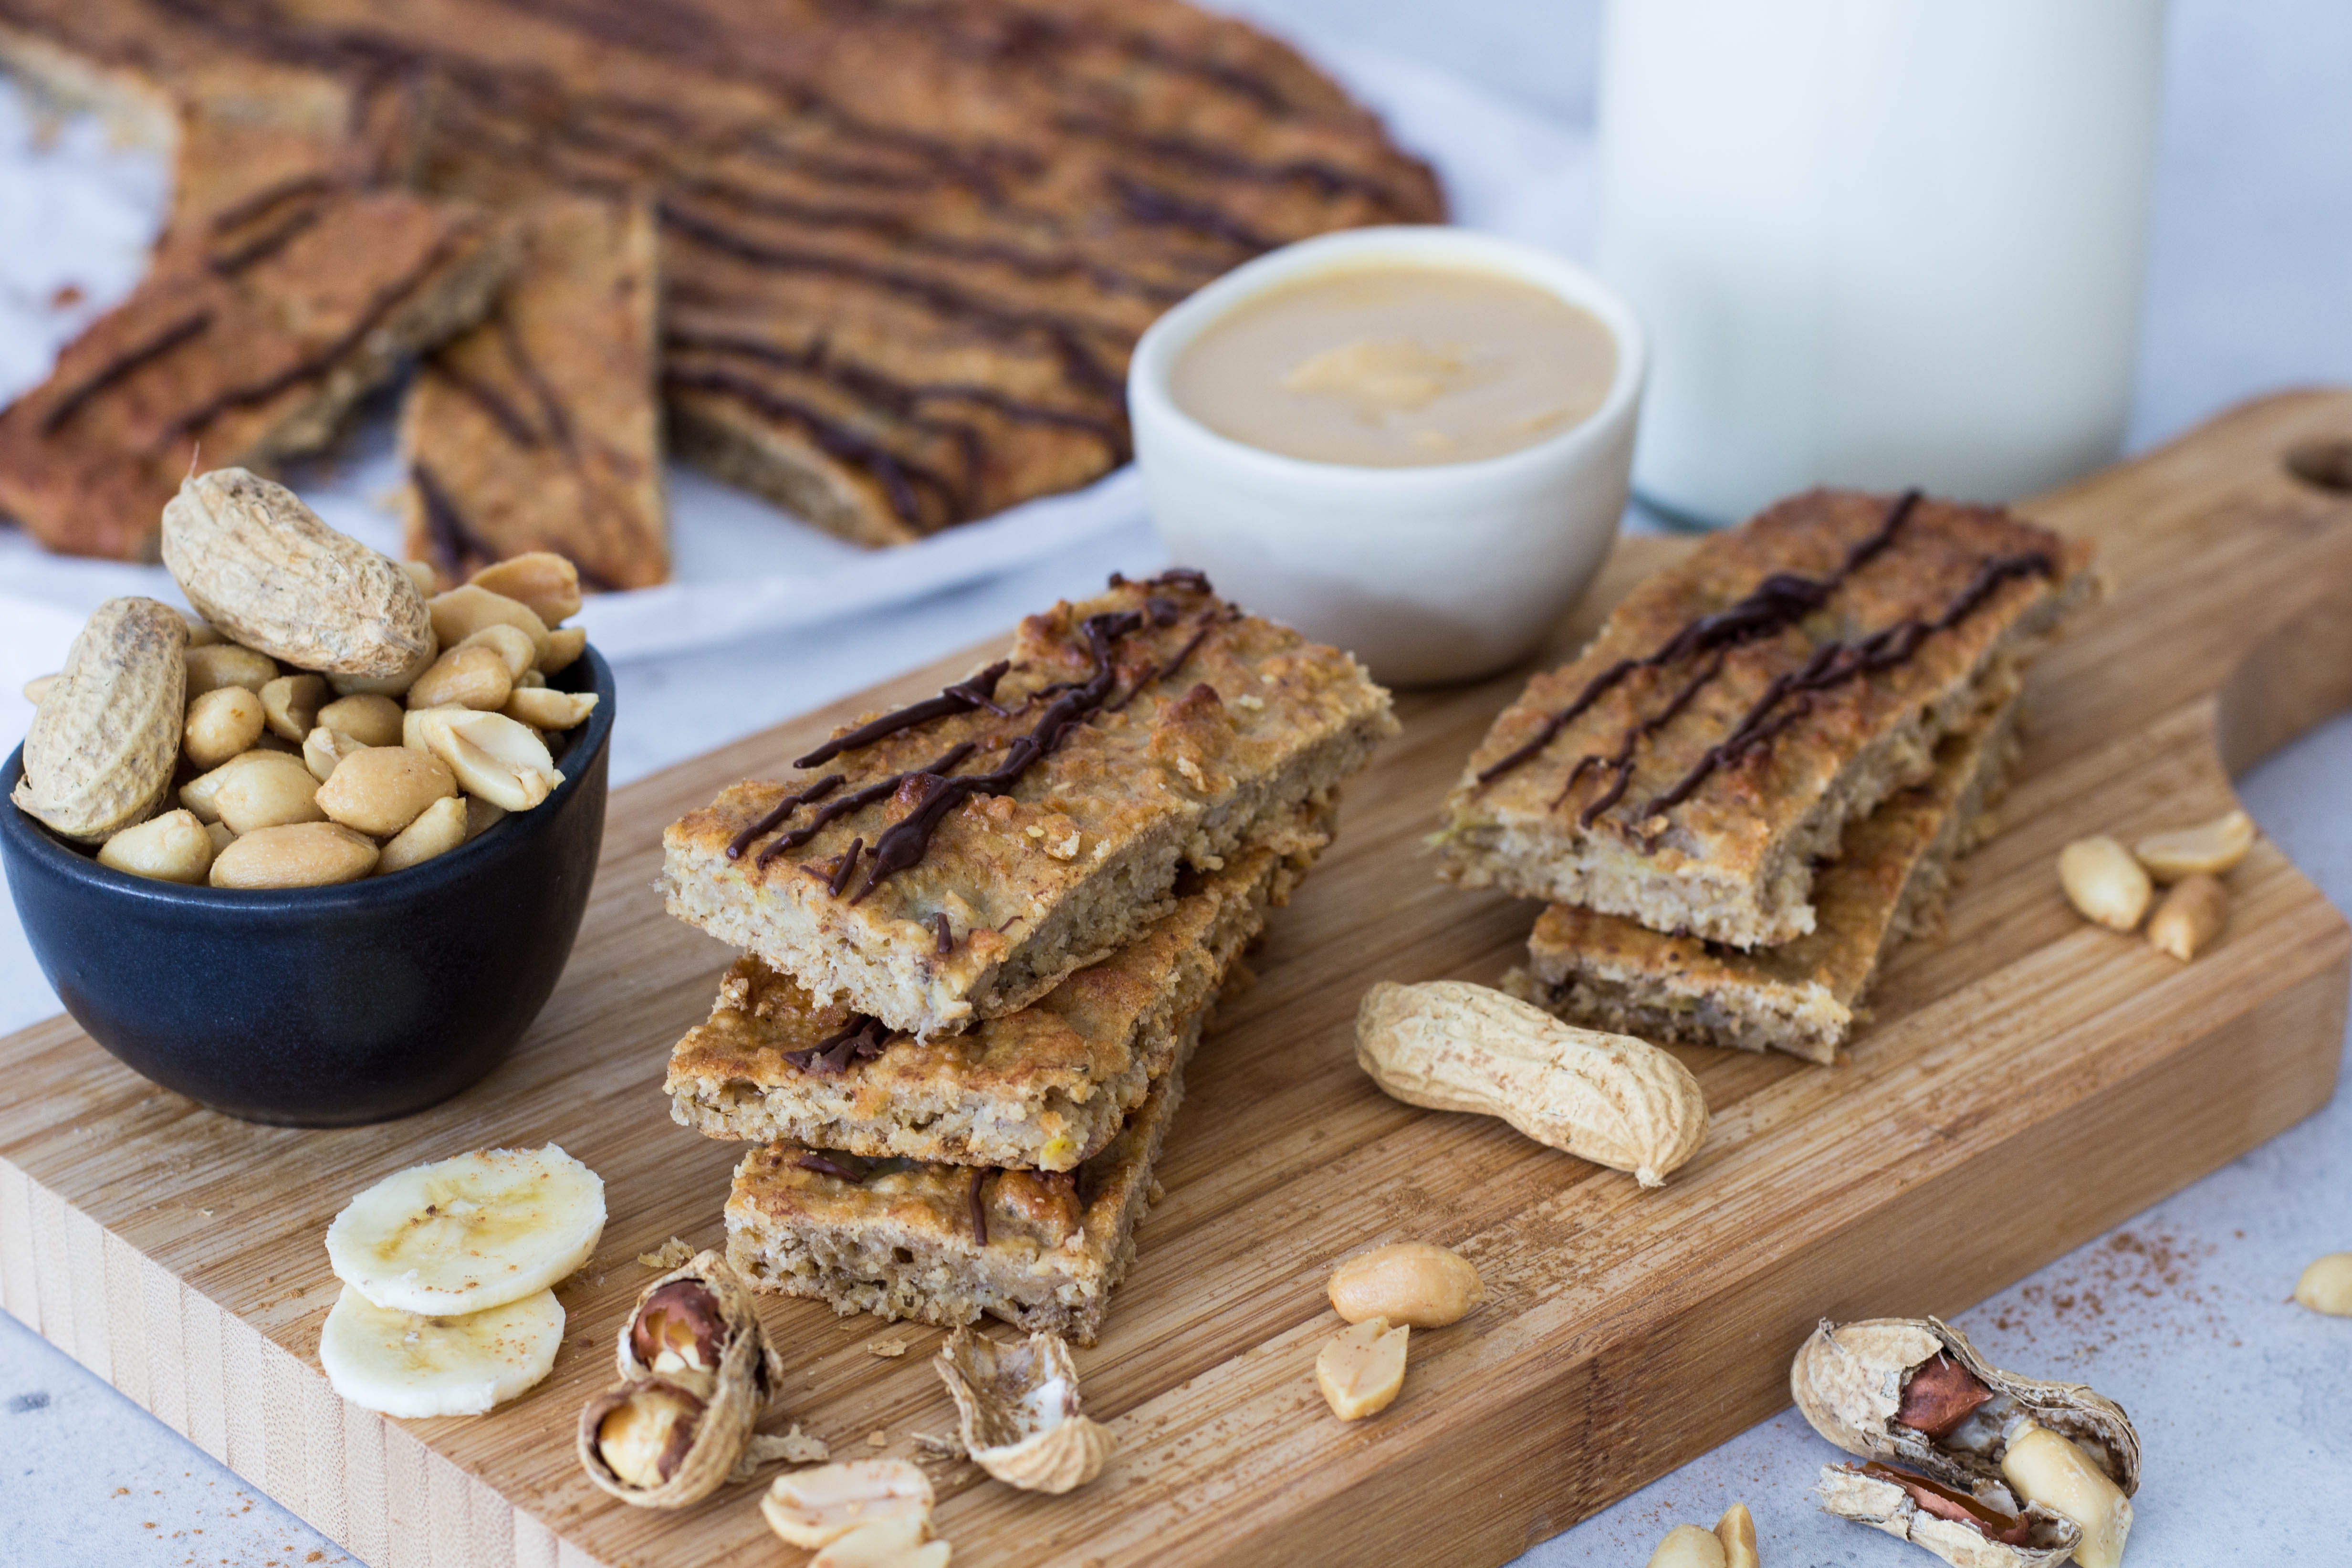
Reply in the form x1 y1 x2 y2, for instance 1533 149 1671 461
0 470 614 1126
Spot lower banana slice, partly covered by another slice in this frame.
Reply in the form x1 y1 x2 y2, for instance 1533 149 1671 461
317 1286 564 1415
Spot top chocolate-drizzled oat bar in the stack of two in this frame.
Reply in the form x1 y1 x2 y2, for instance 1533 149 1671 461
1440 491 2096 947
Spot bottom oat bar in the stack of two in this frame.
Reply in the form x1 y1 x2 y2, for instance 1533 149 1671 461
1503 679 2018 1063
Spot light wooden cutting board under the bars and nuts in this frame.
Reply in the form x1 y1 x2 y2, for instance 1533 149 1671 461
0 393 2352 1568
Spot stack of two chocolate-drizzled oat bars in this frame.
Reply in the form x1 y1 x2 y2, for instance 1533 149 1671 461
1440 491 2096 1063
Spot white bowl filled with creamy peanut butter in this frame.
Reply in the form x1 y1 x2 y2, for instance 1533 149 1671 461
1127 226 1646 687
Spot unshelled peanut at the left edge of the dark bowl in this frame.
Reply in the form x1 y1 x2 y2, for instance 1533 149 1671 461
12 597 188 844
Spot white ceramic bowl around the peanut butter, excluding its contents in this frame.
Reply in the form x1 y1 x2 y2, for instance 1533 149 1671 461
1127 226 1649 687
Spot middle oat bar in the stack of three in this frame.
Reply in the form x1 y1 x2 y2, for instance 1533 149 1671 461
668 820 1327 1171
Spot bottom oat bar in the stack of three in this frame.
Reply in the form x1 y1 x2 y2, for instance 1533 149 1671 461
727 1013 1202 1345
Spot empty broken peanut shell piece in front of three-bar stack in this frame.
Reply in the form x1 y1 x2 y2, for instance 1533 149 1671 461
934 1328 1117 1493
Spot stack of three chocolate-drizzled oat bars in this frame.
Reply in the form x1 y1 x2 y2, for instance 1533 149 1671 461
663 571 1395 1342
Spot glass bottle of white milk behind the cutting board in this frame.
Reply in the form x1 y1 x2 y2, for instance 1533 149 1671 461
1599 0 2164 524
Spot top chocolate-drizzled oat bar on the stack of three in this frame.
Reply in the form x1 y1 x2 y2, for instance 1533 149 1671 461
661 571 1397 1039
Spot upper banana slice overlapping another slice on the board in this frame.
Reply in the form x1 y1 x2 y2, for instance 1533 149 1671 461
327 1142 605 1317
